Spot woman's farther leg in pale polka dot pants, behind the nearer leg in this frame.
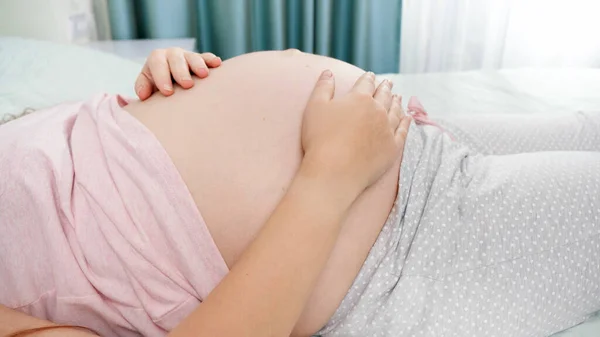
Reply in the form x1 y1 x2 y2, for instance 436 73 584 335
439 112 600 155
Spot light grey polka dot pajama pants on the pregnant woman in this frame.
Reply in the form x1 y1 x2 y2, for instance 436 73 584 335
319 113 600 337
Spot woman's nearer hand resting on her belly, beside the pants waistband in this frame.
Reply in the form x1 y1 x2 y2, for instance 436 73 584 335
301 70 411 197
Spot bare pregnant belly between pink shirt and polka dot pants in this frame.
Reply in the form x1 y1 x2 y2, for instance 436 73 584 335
126 50 400 335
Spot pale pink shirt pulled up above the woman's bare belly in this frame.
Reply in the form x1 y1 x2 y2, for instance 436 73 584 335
0 95 228 336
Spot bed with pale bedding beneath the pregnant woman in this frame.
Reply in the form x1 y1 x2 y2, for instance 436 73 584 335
0 38 600 337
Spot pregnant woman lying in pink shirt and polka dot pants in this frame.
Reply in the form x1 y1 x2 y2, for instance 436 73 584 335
0 50 600 336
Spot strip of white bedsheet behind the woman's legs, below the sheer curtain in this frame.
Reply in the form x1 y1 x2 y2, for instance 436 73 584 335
382 69 600 117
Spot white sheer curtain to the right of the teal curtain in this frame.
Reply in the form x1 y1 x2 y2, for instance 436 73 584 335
400 0 600 73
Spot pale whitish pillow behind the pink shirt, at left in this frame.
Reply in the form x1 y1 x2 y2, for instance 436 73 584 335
0 37 142 121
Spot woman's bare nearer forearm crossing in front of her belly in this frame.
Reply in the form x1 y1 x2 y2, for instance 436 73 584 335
166 166 355 337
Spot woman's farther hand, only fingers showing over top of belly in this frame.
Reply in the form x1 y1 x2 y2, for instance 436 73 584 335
135 48 221 101
